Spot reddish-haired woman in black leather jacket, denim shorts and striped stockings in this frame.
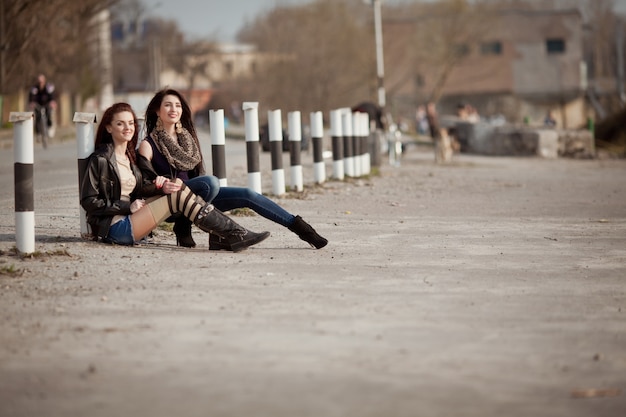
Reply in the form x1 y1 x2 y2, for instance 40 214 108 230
81 103 269 252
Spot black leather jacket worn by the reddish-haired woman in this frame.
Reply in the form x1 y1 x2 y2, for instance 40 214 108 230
80 144 164 239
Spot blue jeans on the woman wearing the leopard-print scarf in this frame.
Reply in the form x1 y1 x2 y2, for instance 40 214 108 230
185 175 296 227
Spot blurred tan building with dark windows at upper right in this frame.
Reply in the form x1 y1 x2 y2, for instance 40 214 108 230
384 8 588 128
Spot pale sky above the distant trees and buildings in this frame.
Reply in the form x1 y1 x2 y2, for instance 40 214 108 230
141 0 626 42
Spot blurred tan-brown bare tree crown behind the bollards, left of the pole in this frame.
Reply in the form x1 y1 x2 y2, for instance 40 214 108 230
234 0 376 118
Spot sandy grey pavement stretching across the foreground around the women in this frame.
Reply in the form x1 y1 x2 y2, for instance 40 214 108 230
0 137 626 417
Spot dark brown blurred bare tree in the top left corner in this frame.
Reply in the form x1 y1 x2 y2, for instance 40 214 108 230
0 0 116 94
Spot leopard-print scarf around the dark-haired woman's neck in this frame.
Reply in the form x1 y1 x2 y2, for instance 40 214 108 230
150 123 202 171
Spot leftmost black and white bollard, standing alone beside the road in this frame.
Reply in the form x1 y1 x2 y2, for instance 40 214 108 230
9 112 35 253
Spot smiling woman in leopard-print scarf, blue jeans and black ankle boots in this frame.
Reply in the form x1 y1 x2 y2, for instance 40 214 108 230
139 89 328 250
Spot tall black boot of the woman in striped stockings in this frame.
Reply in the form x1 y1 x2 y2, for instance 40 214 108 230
194 204 270 252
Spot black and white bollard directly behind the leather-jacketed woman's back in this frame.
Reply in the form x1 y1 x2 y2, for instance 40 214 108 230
73 113 96 239
